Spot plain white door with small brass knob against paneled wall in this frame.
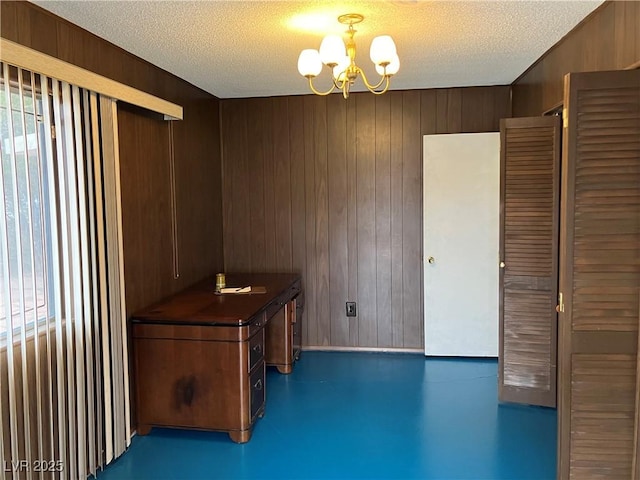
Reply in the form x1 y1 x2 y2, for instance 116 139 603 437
423 132 500 357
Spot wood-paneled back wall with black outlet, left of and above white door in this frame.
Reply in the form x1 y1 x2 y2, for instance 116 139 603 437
221 86 510 348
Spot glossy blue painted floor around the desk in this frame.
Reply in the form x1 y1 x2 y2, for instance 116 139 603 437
98 352 556 480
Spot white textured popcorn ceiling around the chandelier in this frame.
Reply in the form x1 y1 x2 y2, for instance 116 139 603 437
34 0 602 98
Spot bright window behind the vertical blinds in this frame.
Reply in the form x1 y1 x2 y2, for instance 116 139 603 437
0 70 53 342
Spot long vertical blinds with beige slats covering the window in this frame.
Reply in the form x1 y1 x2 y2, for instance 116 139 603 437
0 63 131 479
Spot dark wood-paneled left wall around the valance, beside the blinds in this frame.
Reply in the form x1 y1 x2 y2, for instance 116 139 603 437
0 1 223 313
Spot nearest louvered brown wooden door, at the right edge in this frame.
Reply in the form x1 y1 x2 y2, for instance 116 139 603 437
558 70 640 480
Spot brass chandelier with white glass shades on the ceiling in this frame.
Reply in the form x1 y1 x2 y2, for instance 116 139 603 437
298 13 400 98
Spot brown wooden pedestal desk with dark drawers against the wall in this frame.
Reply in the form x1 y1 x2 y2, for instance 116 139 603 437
131 274 302 443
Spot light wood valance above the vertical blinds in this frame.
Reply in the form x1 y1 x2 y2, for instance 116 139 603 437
0 38 182 120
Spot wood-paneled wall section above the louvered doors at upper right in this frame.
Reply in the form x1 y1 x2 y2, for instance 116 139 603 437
513 1 640 117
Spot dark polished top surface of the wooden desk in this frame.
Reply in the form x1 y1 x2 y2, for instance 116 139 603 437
131 273 300 326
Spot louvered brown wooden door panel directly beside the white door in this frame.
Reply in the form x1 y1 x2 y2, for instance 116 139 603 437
499 117 560 407
